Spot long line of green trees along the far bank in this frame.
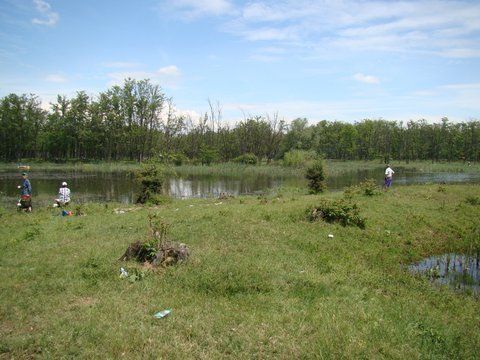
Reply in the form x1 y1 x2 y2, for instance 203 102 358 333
0 79 480 163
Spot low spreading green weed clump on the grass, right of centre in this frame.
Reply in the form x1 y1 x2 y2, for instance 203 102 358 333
306 200 365 229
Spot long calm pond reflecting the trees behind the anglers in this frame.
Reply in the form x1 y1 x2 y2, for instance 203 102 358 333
0 168 480 205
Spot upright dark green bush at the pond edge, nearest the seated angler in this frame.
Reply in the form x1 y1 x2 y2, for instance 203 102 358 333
135 164 165 204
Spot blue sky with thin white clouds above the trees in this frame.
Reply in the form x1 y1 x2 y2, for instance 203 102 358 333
0 0 480 123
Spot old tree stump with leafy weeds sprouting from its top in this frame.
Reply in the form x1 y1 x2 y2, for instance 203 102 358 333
119 214 190 266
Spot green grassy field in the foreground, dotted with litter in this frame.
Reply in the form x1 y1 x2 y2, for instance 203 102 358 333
0 185 480 359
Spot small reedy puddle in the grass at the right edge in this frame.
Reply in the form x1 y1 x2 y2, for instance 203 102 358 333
408 253 480 295
